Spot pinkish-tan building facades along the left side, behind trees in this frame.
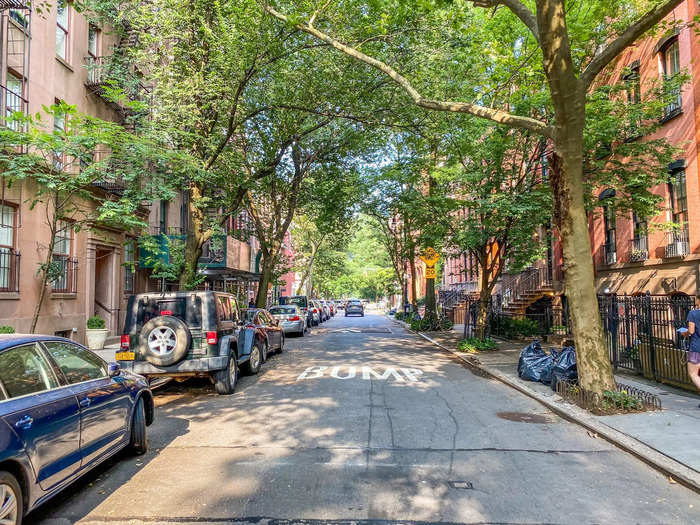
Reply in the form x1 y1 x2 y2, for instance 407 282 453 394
0 0 260 342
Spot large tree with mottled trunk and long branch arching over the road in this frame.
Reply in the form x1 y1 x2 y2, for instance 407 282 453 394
265 0 681 394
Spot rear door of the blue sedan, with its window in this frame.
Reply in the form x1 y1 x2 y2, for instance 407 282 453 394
0 344 80 490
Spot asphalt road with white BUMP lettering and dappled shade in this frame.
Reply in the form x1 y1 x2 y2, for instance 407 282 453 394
26 315 700 525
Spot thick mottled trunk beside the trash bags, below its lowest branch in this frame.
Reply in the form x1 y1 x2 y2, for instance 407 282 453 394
550 133 615 395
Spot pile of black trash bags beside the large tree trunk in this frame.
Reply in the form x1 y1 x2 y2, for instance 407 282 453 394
518 341 578 390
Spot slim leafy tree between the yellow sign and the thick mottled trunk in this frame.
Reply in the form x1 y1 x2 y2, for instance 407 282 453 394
435 121 551 339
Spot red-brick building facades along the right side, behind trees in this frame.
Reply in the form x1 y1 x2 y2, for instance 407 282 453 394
440 0 700 316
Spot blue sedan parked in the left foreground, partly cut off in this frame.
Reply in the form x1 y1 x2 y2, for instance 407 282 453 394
0 334 153 525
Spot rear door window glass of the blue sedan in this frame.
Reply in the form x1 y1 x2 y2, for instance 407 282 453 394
0 344 58 398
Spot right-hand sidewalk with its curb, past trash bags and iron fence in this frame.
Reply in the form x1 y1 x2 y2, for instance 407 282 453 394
395 321 700 491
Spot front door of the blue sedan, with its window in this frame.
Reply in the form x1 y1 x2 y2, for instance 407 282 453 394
45 341 131 467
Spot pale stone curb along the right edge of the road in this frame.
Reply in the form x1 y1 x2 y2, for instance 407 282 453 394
393 320 700 493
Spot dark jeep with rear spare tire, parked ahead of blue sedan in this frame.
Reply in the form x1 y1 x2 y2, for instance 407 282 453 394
116 291 265 394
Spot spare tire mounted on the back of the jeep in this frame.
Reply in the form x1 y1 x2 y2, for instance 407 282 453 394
139 315 192 366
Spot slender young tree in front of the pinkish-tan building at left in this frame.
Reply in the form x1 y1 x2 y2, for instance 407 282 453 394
0 102 169 333
